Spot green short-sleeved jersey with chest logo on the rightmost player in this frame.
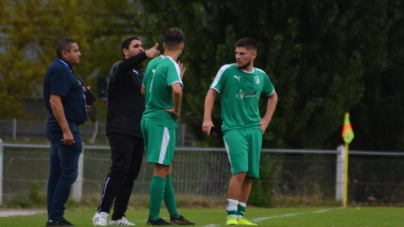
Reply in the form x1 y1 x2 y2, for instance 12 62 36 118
210 64 275 131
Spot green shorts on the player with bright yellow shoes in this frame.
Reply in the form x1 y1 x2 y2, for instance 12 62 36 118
223 128 262 178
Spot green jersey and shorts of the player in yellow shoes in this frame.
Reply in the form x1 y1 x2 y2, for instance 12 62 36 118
210 64 275 178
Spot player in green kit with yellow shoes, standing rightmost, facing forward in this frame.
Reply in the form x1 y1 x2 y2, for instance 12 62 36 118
202 38 278 225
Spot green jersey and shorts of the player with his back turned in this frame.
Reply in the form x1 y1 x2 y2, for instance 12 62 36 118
141 55 182 166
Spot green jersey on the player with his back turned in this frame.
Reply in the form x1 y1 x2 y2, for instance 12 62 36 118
142 55 182 128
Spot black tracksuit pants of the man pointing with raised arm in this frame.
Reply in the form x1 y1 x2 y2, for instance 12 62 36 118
98 133 144 220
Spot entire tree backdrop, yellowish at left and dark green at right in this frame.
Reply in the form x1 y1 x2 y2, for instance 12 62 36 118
0 0 404 151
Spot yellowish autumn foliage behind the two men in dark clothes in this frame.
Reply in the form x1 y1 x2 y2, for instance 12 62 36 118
0 0 145 120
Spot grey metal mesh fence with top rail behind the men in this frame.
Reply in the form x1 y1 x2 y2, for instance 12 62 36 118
0 142 404 204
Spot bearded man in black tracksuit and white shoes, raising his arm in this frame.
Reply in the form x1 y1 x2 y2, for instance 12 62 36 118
93 37 160 226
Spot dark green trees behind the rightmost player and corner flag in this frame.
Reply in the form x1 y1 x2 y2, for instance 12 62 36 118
141 0 404 150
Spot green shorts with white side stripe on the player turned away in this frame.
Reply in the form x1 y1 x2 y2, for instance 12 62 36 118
140 119 176 166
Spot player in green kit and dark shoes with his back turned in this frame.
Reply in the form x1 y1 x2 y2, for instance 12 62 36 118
141 28 195 225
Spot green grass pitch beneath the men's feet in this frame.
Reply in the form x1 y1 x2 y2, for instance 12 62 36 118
0 207 404 227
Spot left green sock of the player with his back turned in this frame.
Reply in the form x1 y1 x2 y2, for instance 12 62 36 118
149 176 166 221
